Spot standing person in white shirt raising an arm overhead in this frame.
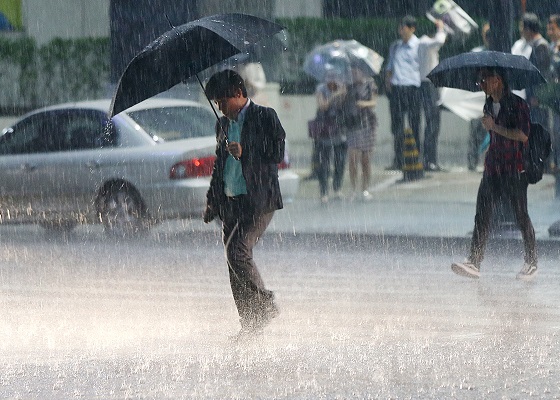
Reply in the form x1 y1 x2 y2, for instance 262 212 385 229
418 20 447 171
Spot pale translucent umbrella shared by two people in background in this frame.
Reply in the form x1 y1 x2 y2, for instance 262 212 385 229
303 40 383 82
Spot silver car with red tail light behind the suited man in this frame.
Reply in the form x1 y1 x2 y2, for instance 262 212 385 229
0 99 299 236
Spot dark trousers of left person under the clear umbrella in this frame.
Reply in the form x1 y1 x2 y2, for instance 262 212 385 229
317 141 348 196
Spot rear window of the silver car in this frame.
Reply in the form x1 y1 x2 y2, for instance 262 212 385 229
127 106 216 142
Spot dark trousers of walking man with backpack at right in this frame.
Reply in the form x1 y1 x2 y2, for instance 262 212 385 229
469 174 537 266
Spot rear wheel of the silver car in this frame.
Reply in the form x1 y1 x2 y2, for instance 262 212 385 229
101 186 148 237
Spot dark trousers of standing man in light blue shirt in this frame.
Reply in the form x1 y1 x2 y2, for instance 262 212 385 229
389 86 421 168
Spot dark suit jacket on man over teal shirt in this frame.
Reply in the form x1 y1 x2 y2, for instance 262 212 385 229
207 101 286 220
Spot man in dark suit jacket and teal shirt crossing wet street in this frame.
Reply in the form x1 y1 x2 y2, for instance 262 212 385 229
204 70 286 340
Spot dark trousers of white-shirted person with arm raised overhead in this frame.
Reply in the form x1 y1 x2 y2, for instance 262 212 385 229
416 82 441 165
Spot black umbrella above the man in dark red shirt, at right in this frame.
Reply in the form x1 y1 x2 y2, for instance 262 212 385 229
428 51 546 92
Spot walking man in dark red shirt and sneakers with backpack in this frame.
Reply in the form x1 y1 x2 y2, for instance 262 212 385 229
451 68 537 280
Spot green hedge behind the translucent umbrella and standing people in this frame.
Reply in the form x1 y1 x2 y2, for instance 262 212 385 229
278 18 480 93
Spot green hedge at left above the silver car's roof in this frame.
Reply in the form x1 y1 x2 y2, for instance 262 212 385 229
0 36 110 111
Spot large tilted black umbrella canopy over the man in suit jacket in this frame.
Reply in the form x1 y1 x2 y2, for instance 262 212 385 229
109 14 284 116
